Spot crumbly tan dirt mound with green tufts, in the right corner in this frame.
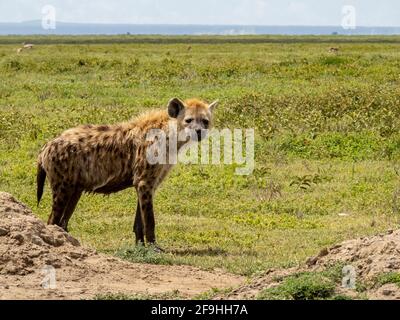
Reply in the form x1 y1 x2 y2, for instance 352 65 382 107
220 230 400 299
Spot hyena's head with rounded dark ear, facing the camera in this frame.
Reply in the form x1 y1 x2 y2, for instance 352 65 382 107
168 98 218 141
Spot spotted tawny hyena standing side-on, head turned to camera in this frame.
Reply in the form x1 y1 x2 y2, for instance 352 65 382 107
37 98 217 243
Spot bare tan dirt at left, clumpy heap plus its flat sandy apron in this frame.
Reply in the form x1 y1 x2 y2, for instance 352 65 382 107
0 192 243 299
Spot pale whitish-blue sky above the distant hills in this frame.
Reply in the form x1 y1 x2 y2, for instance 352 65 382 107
0 0 400 26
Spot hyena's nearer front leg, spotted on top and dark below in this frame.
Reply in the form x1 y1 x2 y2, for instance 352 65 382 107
137 182 156 243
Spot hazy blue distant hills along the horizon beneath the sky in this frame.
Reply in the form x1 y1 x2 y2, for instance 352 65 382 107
0 20 400 35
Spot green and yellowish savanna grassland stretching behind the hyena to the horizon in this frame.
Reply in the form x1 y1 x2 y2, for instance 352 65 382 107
0 36 400 275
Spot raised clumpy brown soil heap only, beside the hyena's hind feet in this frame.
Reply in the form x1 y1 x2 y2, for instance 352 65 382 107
0 193 83 275
